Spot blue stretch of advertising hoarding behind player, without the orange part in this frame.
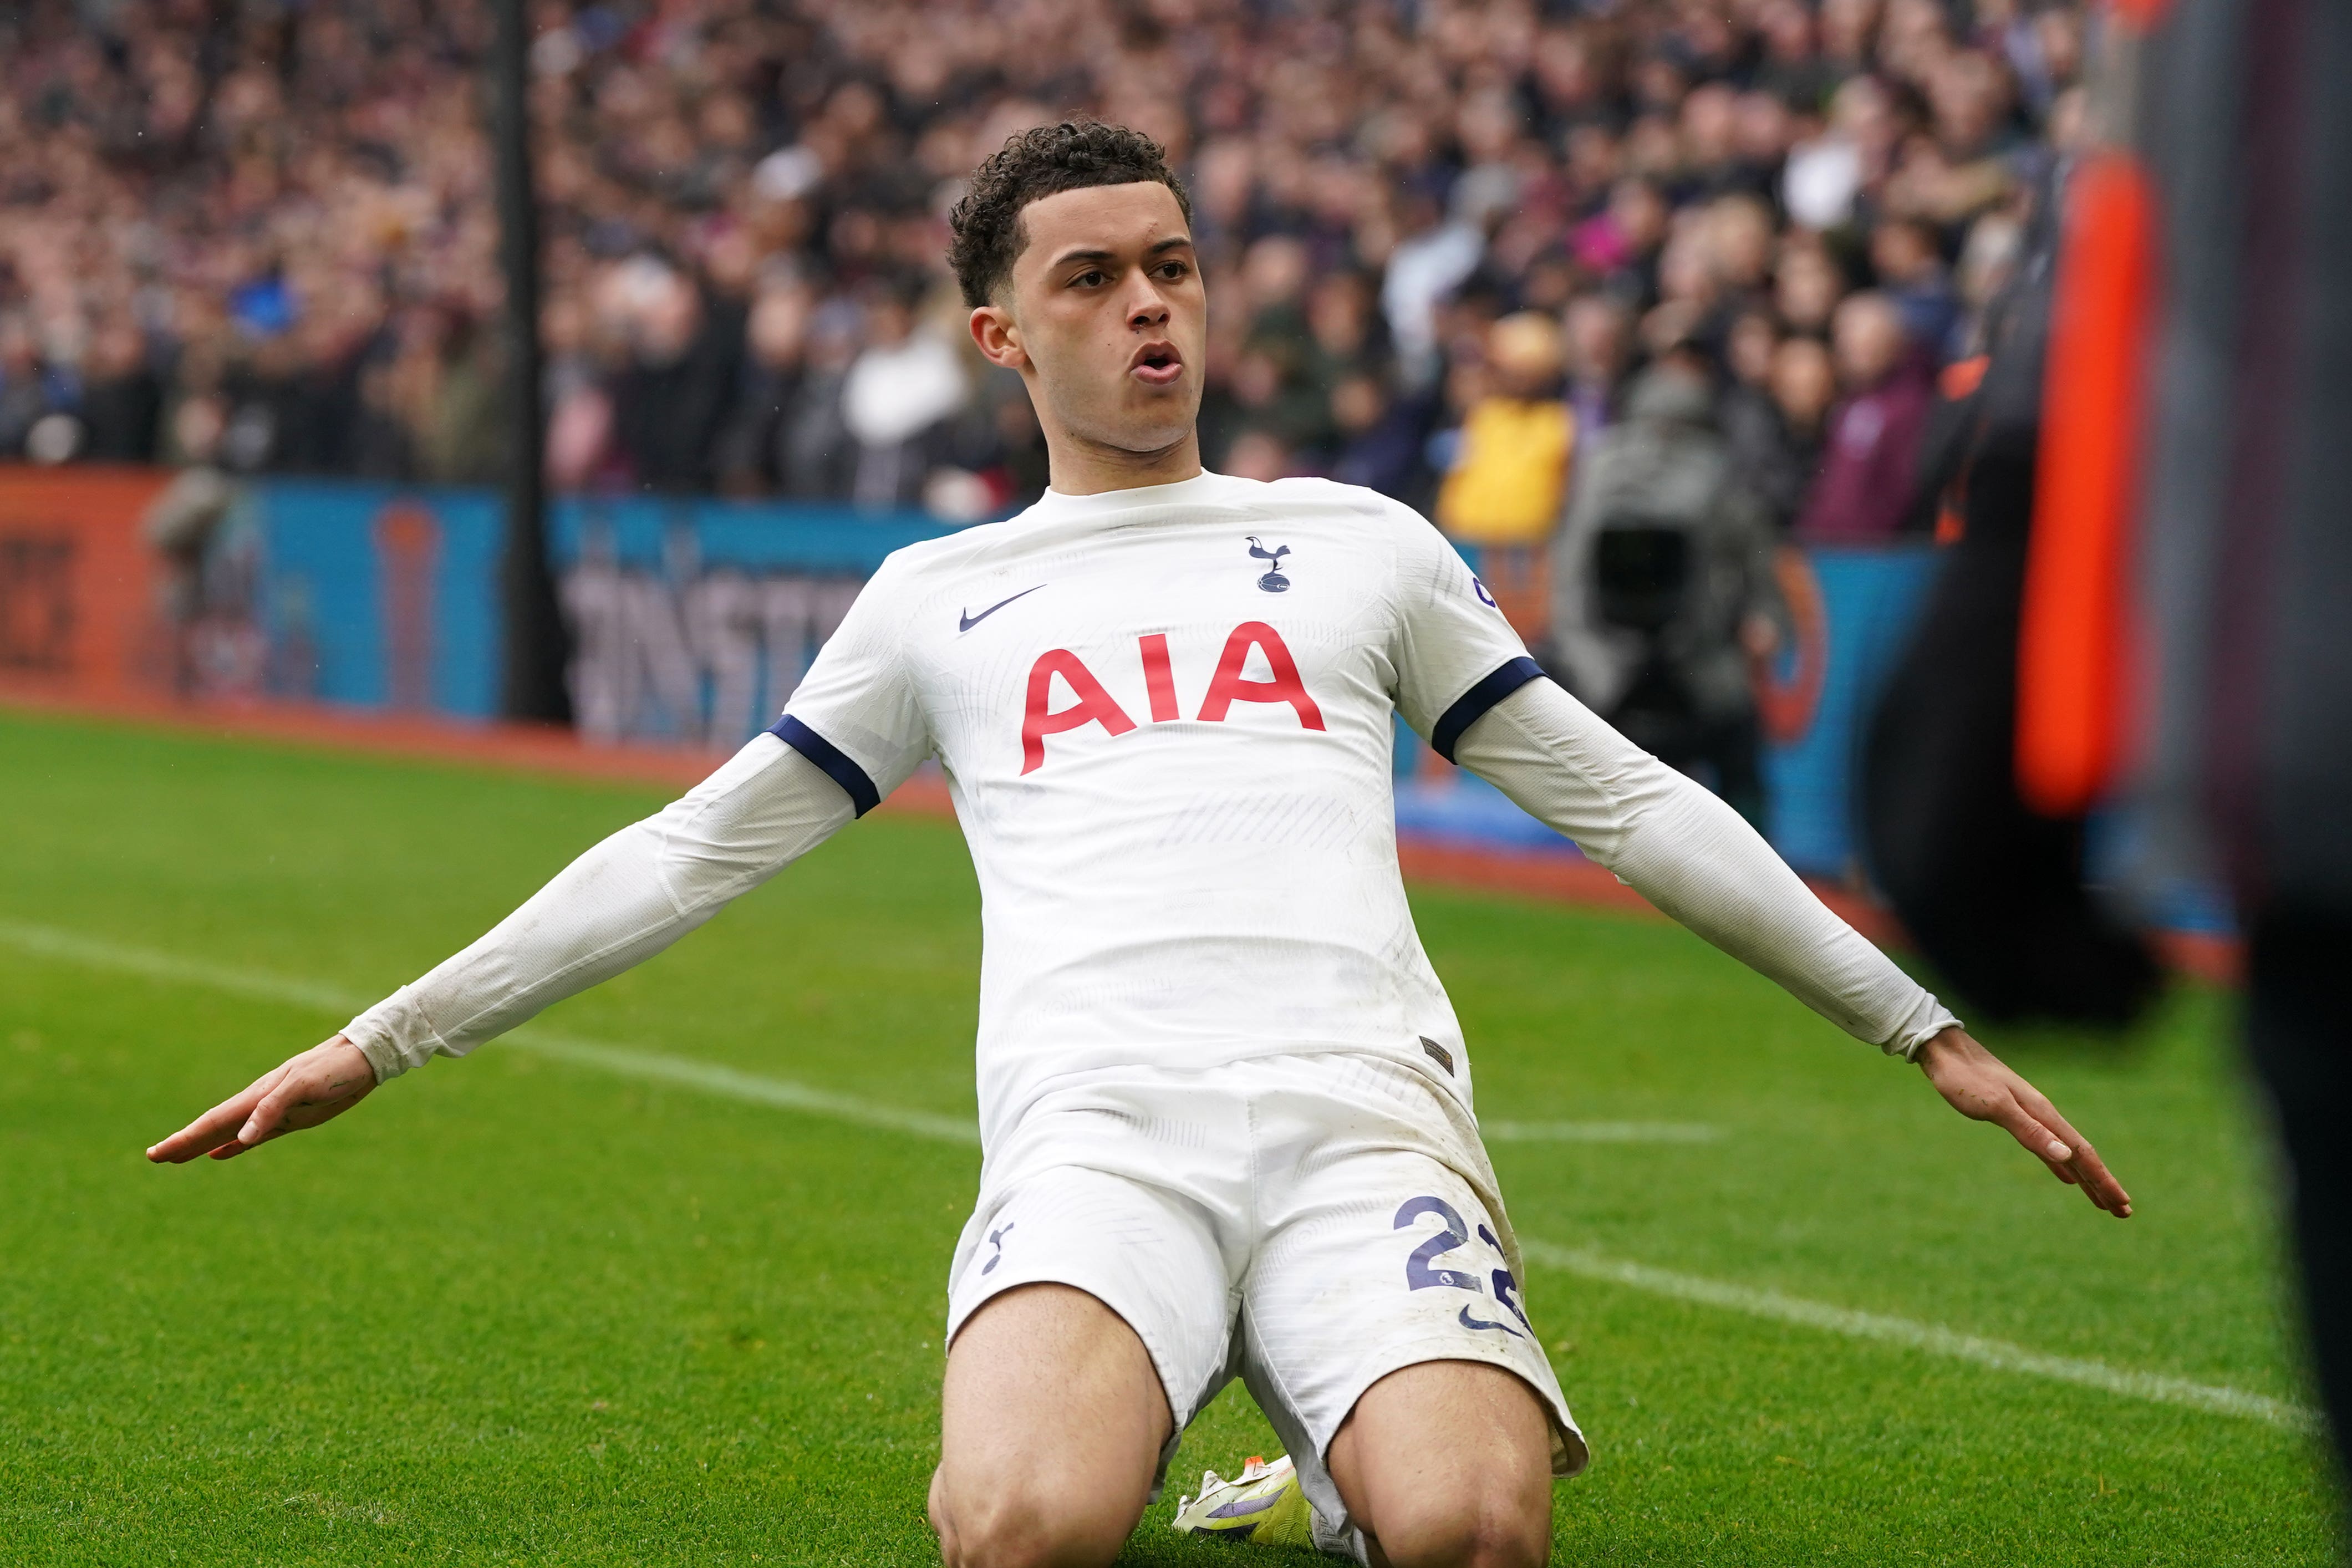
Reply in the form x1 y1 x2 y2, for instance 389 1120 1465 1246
156 480 1936 877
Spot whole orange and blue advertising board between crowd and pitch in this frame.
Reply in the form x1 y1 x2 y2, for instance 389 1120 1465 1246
0 468 1936 879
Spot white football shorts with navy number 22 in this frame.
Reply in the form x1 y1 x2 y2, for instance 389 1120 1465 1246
948 1053 1585 1549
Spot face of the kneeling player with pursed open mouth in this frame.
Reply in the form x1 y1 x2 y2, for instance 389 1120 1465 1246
971 181 1209 451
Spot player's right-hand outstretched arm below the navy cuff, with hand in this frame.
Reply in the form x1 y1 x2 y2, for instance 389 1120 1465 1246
1456 679 2131 1218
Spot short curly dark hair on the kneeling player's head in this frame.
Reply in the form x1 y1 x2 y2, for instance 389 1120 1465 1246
948 120 1193 306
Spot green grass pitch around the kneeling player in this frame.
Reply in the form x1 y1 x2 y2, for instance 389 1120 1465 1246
0 715 2333 1566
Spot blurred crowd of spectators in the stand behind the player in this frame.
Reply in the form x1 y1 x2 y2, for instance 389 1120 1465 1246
0 0 2084 649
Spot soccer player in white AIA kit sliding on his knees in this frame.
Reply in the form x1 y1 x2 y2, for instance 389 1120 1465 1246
148 122 2131 1568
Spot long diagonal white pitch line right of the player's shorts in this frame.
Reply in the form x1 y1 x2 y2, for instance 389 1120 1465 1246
1519 1239 2322 1432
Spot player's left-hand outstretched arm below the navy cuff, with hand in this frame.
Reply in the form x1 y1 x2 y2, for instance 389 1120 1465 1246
148 736 854 1164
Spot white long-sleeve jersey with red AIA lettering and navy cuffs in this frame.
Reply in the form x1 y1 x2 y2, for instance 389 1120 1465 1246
348 475 1954 1143
